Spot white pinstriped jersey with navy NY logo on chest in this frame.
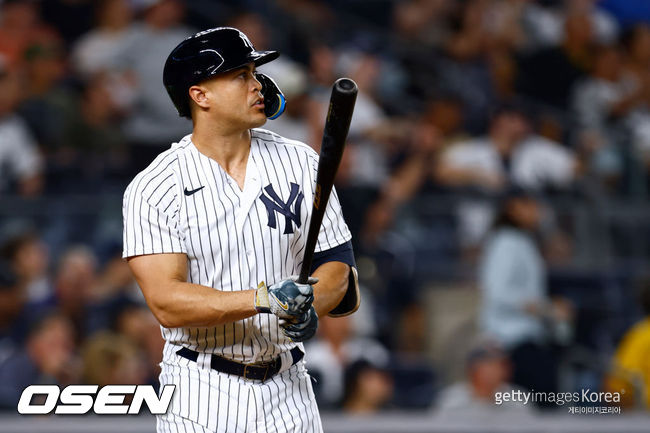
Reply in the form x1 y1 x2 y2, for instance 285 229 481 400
123 129 351 363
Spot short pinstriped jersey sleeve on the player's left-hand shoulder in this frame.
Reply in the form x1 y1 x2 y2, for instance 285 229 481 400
122 169 187 258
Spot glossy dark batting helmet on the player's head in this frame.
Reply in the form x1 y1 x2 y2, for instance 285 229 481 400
163 27 280 117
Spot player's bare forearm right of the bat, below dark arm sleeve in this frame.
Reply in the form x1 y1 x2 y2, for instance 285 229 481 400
312 262 350 316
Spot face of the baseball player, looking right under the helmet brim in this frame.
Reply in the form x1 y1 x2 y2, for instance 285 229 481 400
195 63 266 130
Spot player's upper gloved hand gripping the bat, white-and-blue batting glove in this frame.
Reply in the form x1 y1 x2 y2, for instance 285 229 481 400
255 276 318 319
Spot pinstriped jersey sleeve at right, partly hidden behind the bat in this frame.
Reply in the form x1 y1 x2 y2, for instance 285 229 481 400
308 152 352 253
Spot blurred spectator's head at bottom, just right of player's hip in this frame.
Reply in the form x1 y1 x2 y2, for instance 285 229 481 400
343 359 393 415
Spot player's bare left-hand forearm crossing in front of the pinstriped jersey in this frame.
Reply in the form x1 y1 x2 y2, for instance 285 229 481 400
147 281 257 328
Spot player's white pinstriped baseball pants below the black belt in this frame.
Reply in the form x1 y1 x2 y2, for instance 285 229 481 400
157 359 322 433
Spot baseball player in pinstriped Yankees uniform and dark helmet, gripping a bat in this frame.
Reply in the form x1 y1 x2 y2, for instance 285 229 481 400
123 27 359 433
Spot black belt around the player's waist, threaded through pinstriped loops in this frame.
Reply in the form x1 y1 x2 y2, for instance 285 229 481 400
176 347 305 382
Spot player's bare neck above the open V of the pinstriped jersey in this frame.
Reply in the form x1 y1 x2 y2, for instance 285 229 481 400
192 126 251 173
